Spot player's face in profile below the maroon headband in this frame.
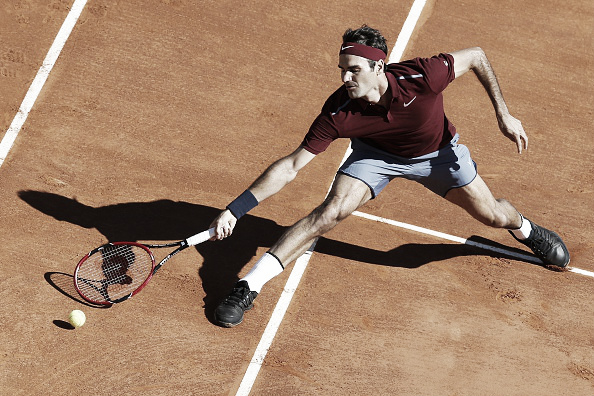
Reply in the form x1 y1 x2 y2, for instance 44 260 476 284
338 54 381 99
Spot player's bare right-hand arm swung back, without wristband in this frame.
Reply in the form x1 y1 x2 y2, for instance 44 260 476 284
451 47 528 154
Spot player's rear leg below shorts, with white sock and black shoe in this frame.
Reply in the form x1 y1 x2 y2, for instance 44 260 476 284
445 175 570 268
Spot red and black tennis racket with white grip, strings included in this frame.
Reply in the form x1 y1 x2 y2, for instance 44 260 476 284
74 228 214 305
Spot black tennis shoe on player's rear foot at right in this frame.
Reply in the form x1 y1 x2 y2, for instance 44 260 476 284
509 218 569 268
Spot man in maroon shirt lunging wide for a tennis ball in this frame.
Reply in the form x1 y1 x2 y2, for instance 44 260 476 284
211 26 569 327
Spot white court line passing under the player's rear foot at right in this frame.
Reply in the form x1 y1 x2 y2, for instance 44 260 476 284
353 211 594 278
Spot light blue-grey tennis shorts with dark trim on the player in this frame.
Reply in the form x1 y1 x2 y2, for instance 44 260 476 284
338 134 477 198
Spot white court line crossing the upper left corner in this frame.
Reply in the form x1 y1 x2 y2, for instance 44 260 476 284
0 0 87 166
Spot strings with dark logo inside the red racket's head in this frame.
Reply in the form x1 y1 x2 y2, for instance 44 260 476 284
76 244 154 303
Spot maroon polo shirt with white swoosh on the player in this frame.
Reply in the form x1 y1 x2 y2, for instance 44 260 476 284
301 54 456 158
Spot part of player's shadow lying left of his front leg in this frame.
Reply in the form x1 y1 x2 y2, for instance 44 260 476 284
18 190 284 320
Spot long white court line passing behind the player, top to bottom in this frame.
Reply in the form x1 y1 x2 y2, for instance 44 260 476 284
235 0 426 396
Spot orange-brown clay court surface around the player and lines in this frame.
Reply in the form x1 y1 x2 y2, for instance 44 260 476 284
0 0 594 396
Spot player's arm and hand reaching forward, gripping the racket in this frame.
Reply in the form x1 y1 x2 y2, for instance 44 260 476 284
210 147 315 239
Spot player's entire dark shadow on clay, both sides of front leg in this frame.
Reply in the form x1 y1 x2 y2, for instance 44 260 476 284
18 190 540 321
